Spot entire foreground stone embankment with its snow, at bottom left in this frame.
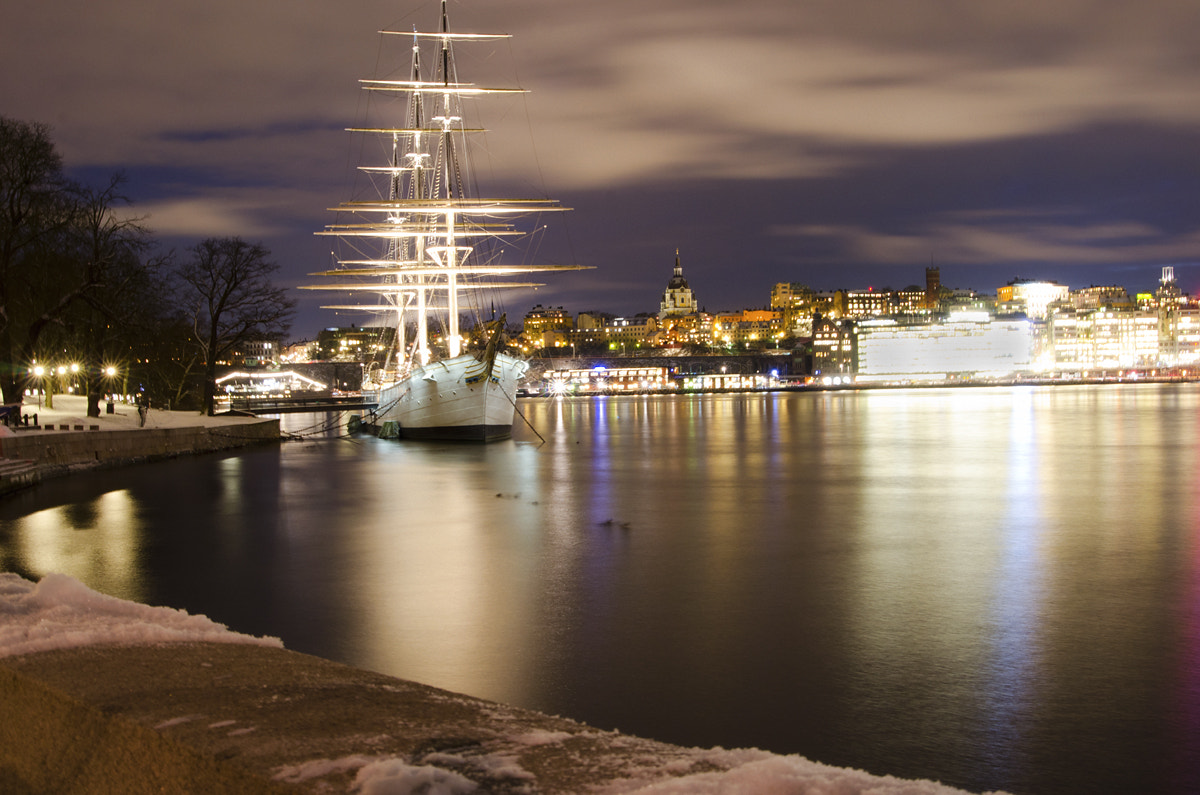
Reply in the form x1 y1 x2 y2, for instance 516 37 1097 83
0 574 988 795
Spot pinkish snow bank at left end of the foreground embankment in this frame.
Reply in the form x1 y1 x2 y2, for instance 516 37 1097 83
0 572 283 657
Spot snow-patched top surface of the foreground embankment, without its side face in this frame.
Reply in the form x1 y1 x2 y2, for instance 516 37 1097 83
0 573 993 795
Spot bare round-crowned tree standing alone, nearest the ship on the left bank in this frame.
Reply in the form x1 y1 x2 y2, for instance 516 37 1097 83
179 238 295 416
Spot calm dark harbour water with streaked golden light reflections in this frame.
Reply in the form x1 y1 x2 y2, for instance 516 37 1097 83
0 384 1200 793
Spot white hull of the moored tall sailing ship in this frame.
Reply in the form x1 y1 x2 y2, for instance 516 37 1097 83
376 353 529 442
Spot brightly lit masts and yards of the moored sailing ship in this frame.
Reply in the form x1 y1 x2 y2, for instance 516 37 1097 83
301 0 582 367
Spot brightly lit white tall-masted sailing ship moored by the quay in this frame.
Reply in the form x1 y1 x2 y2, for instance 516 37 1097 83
302 0 582 442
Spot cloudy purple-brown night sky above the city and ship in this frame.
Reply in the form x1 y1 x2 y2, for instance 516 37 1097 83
9 0 1200 339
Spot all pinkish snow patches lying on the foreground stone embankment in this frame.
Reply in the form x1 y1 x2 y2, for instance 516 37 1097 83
0 572 993 795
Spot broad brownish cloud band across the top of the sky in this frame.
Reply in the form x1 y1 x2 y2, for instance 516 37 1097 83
9 0 1200 190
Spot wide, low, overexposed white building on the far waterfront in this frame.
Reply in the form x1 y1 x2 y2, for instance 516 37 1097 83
856 312 1033 382
